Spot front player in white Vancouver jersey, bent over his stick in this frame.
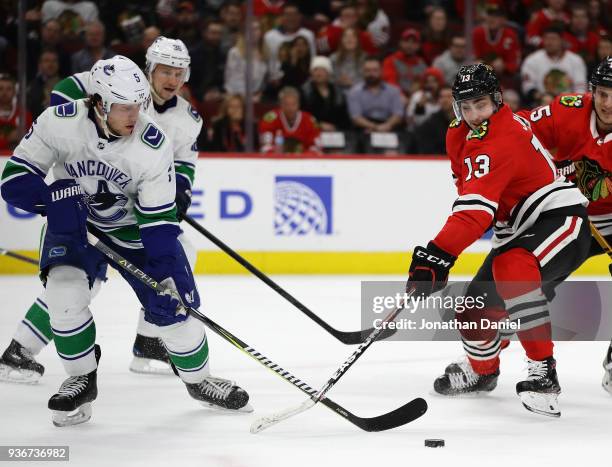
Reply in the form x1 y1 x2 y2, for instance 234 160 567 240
0 56 252 426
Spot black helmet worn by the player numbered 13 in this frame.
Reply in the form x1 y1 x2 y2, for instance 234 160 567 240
453 63 503 120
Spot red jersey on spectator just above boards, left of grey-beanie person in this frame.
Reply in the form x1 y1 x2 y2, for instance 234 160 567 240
259 109 321 153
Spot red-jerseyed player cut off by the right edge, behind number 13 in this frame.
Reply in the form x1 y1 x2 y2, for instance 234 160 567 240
520 57 612 393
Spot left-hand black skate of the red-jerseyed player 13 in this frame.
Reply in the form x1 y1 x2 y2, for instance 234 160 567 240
434 357 499 396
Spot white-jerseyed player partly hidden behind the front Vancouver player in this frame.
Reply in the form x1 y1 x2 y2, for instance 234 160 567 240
0 37 202 383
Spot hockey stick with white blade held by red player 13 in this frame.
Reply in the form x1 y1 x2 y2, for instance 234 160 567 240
251 289 414 433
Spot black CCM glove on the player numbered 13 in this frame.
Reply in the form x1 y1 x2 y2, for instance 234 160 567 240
406 242 457 296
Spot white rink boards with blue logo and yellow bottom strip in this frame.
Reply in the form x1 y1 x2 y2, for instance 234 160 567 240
0 154 608 275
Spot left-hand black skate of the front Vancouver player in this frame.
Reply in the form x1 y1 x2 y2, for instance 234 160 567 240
48 345 101 427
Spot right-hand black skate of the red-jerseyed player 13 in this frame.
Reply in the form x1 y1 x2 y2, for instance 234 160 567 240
516 357 561 417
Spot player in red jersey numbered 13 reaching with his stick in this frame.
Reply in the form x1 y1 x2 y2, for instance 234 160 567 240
407 64 590 416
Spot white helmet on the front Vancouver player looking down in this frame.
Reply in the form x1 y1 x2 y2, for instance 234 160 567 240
89 55 151 116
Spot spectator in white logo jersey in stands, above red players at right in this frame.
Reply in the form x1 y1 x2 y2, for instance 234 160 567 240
521 26 587 104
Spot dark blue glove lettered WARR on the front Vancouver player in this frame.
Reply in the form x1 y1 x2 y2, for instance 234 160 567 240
45 179 87 247
